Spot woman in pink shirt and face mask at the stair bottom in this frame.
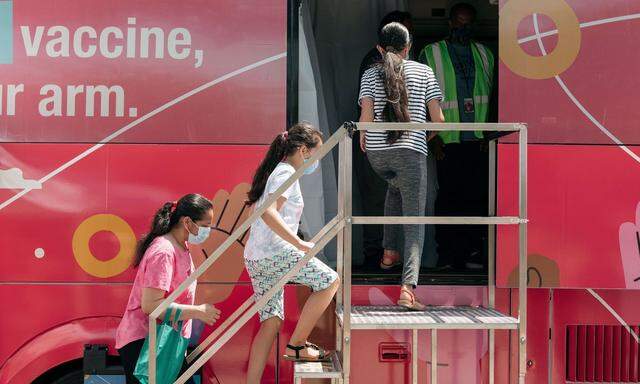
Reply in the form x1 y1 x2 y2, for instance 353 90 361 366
116 194 220 384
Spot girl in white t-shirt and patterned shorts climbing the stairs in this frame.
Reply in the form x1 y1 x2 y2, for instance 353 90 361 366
244 122 339 383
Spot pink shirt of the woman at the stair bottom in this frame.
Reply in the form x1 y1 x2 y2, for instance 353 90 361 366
116 235 196 349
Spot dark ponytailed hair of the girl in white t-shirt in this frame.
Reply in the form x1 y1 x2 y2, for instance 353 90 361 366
247 121 322 205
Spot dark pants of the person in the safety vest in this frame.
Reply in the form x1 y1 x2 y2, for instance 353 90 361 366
436 141 489 269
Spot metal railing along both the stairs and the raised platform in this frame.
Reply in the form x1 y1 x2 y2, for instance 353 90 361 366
149 123 527 384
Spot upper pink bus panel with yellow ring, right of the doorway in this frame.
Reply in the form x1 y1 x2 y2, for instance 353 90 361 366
499 0 640 146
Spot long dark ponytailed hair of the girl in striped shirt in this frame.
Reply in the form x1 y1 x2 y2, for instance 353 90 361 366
378 22 411 144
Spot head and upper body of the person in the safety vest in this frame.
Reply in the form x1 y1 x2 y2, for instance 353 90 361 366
418 3 494 145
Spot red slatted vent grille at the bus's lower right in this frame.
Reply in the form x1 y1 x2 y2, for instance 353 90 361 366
565 325 640 383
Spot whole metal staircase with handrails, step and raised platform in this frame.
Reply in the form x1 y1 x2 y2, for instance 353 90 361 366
149 123 527 384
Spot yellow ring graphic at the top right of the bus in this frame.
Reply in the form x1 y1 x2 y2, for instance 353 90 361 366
500 0 580 79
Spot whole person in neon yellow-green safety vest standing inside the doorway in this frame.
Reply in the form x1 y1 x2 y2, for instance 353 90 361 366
418 3 494 270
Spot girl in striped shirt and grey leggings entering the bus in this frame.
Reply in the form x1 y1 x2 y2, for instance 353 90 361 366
358 23 444 310
